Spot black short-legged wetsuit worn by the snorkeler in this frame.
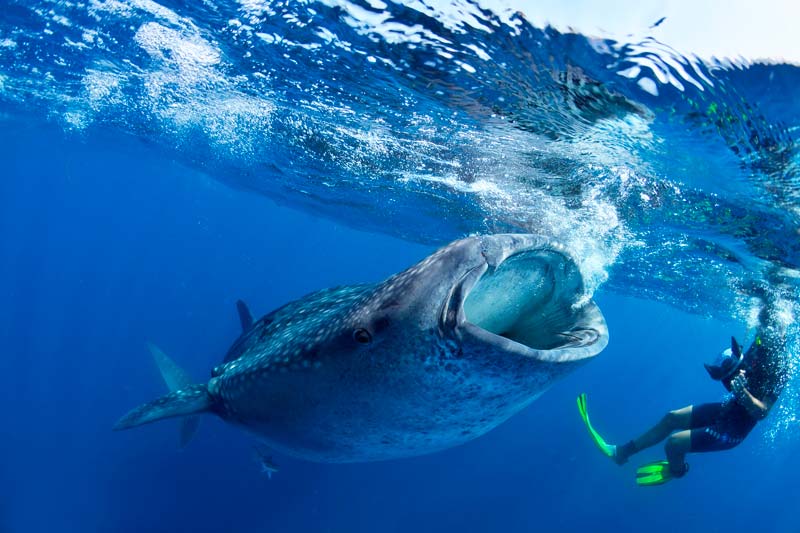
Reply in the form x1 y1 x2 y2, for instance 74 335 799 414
689 332 788 452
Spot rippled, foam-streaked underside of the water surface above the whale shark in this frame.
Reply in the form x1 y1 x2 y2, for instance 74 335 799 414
0 0 800 318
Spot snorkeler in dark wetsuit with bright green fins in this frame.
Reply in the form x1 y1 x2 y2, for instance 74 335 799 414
578 288 788 486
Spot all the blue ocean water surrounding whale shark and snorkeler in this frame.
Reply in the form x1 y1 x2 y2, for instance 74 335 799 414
0 0 800 532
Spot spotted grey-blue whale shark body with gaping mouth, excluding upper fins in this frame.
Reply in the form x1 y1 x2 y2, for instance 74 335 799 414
117 235 608 462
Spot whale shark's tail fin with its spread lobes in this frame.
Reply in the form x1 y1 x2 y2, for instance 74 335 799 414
114 343 210 438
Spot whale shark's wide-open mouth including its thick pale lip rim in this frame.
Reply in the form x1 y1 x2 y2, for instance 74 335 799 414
447 247 608 362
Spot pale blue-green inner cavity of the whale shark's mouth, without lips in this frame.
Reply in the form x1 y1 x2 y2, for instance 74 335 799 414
463 250 597 351
